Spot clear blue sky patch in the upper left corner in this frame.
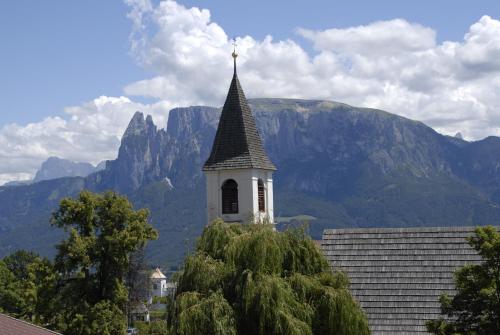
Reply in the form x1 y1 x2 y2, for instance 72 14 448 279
0 0 138 125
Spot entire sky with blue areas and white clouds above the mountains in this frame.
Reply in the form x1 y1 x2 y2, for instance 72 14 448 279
0 0 500 184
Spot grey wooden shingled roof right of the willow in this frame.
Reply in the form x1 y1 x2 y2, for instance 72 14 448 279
321 227 481 335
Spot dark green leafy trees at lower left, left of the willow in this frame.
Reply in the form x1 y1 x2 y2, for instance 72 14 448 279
0 191 157 335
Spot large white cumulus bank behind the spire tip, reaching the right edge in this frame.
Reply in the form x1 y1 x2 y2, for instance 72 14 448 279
125 0 500 139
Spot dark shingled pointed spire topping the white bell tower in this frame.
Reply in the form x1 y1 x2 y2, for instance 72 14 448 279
203 52 276 171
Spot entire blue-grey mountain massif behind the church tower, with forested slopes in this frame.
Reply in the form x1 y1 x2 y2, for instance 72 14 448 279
0 99 500 268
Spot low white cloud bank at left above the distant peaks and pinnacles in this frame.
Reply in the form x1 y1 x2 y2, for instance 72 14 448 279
0 96 171 185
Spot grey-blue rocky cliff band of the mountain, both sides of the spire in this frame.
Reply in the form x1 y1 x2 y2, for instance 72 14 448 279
91 99 488 197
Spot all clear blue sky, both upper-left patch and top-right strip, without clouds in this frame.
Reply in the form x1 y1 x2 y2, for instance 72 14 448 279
0 0 500 126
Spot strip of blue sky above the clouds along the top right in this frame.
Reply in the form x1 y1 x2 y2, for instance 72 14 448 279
189 0 500 40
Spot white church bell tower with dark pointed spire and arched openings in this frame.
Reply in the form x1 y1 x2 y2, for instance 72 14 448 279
203 51 276 223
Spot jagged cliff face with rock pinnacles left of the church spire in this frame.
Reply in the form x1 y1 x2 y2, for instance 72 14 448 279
90 107 219 193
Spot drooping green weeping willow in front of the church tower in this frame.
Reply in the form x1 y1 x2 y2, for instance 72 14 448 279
168 221 370 335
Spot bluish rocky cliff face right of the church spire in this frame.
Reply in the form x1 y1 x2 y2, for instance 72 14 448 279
252 99 449 196
